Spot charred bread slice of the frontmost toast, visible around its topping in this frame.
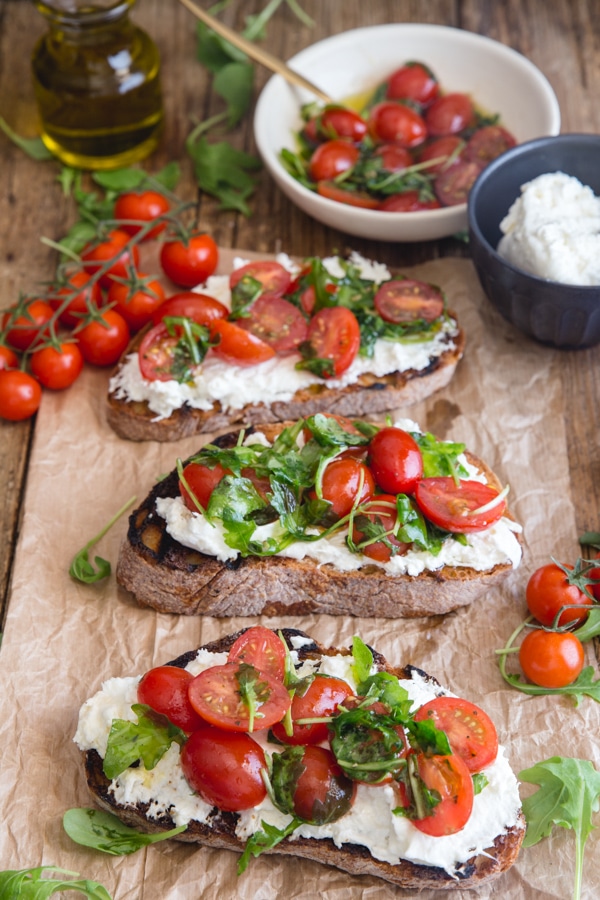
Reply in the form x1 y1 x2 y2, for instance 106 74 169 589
83 628 525 891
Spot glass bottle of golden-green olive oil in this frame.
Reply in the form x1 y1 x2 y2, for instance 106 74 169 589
32 0 163 169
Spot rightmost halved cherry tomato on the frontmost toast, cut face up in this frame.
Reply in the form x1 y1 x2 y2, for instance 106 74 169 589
415 697 498 772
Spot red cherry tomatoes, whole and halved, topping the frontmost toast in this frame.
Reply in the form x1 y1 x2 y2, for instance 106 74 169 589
138 626 498 835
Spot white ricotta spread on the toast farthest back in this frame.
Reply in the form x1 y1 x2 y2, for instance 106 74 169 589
109 253 458 421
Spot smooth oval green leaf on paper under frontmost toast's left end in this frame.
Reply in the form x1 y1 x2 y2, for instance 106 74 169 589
63 808 187 856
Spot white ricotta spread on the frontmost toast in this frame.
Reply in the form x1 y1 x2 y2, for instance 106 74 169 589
73 650 521 875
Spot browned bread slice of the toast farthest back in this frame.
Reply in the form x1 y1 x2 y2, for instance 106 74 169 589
107 313 465 442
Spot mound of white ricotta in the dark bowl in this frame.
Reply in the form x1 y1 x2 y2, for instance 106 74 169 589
498 172 600 285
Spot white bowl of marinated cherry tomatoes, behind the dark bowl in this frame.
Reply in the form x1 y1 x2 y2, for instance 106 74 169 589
254 24 560 242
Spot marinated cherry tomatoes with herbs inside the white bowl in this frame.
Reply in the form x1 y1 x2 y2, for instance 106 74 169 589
292 62 516 212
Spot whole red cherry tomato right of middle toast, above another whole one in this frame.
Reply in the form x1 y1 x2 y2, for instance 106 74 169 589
525 563 593 626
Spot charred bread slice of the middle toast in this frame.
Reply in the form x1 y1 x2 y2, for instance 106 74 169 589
116 423 512 618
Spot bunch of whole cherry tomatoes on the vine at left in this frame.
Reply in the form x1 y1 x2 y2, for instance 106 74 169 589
0 190 218 421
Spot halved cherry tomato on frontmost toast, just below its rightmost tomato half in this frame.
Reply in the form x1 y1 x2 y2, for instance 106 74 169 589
413 753 473 837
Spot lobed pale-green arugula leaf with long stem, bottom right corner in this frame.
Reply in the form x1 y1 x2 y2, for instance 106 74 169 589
519 756 600 900
